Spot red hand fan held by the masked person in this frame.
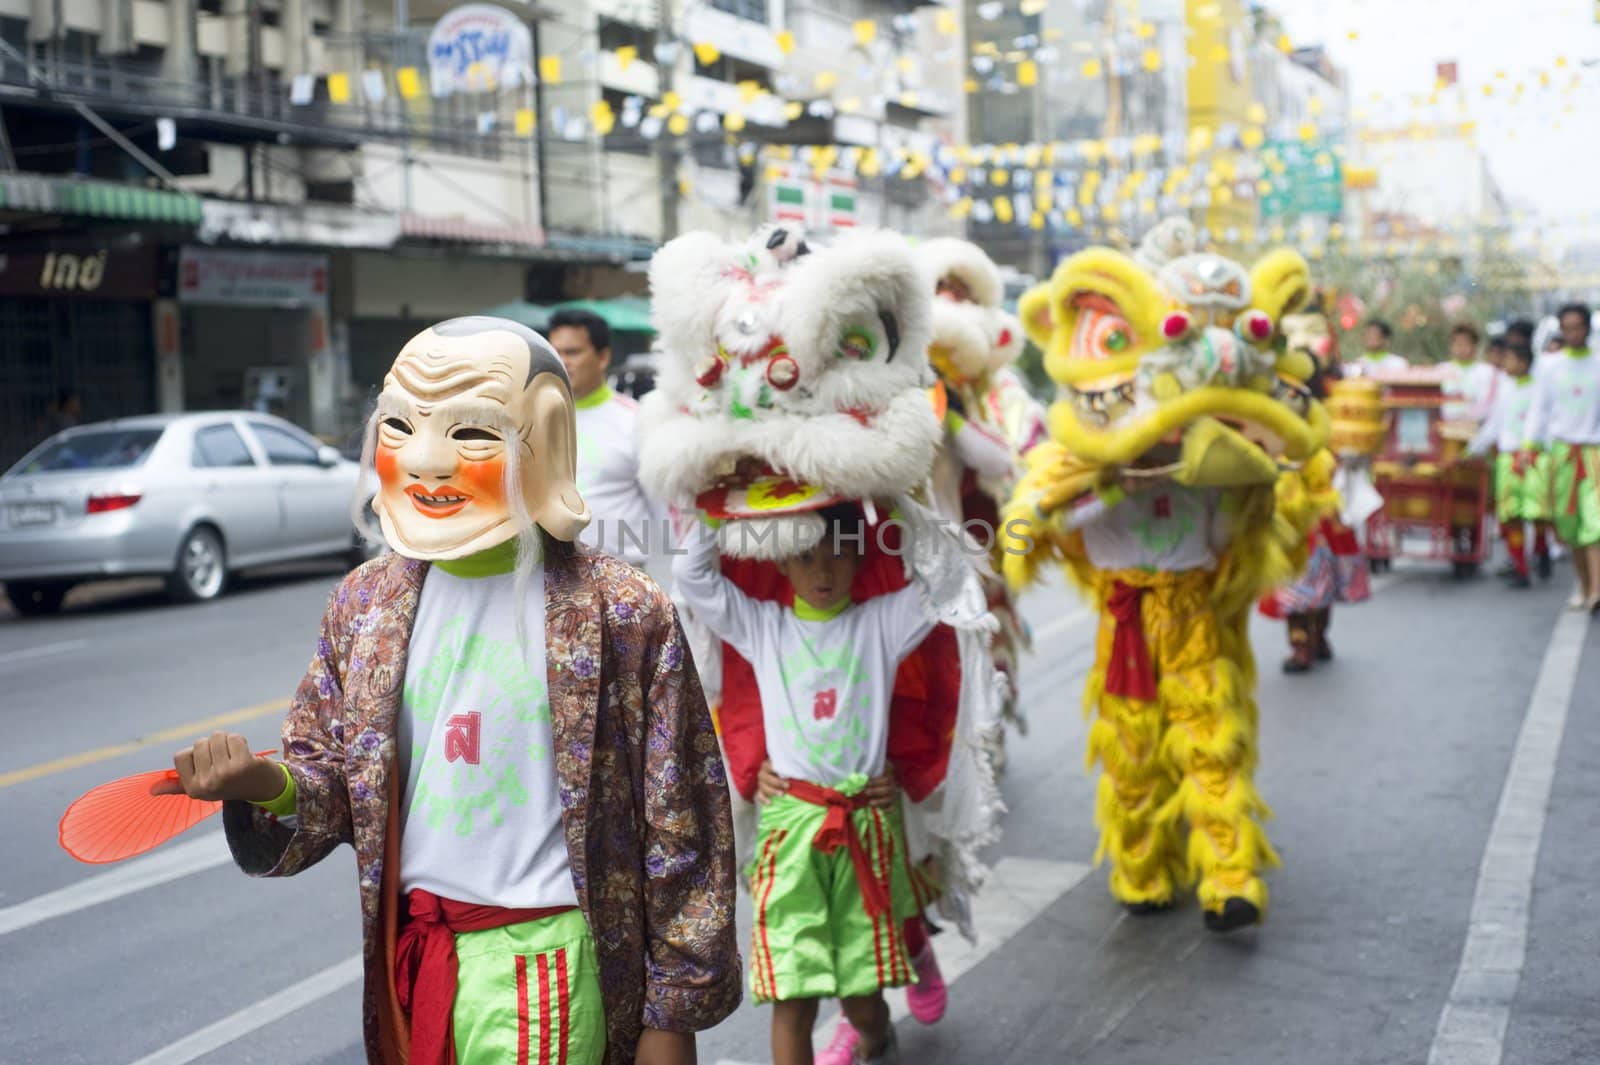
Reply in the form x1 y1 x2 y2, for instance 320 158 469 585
56 750 277 865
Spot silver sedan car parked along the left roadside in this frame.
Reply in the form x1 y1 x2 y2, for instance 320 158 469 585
0 411 368 614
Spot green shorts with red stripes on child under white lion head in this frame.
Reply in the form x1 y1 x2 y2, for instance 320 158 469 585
749 777 920 1003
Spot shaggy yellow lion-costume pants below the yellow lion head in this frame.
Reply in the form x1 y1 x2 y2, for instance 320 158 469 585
1085 569 1278 915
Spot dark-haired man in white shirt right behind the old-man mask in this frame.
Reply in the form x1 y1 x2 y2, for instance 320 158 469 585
546 310 667 566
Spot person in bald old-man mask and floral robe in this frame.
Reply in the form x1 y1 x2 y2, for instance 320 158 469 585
165 318 739 1065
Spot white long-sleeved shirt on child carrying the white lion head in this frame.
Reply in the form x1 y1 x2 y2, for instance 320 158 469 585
672 529 933 787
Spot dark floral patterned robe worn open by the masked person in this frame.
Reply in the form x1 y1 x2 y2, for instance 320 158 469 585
224 550 741 1065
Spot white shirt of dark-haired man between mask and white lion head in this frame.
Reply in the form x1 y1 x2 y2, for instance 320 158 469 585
573 385 667 564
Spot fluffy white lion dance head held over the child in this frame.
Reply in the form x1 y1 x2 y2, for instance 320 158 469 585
640 229 941 558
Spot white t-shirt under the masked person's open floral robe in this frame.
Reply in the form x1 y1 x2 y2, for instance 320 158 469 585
398 550 578 907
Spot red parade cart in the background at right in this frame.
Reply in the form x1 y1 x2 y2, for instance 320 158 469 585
1366 368 1491 577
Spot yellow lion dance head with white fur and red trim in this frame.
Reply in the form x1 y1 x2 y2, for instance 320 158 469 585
1006 219 1328 582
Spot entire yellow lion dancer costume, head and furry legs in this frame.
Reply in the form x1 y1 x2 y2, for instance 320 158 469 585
1005 219 1328 931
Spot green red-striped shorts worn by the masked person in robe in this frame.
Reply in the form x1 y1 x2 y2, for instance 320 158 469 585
451 910 605 1065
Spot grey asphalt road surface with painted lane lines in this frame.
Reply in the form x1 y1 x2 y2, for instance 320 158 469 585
0 556 1600 1065
